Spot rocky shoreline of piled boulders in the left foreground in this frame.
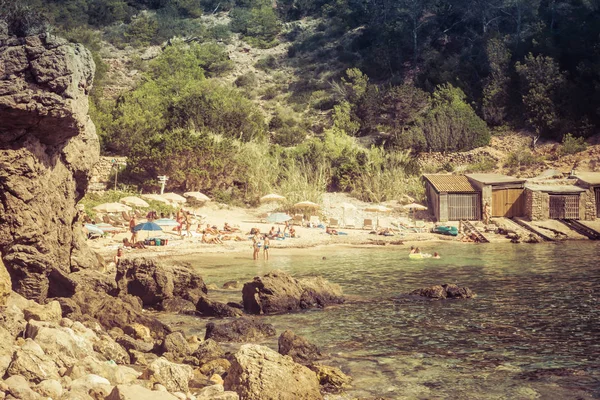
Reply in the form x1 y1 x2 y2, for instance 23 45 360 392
0 258 351 400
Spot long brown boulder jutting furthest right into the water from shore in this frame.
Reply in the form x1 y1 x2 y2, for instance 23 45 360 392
242 271 344 314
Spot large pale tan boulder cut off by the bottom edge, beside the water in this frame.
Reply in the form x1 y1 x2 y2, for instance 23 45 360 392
224 344 323 400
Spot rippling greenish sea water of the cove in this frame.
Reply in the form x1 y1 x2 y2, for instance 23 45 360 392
166 241 600 399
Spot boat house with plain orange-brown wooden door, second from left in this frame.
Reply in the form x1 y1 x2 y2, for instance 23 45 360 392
466 174 526 218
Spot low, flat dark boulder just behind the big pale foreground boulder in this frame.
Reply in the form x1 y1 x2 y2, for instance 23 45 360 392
204 318 276 342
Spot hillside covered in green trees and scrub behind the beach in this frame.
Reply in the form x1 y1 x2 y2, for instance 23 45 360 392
0 0 600 203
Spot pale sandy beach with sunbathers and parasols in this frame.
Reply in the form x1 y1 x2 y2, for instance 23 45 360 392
88 193 456 261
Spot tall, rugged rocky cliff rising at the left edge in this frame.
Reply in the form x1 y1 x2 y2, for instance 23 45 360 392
0 34 99 301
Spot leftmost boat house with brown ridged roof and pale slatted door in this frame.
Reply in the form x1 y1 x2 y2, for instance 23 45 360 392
423 174 482 222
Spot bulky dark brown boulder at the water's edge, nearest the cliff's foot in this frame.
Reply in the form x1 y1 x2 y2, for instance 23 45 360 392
116 257 208 308
